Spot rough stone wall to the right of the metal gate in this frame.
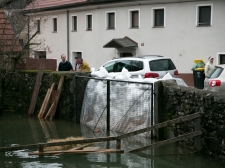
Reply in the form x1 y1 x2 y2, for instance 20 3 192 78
156 81 225 160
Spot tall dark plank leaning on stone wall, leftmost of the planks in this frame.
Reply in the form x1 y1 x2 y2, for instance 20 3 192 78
28 63 45 116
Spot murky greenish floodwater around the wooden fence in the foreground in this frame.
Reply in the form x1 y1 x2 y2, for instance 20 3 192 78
0 113 225 168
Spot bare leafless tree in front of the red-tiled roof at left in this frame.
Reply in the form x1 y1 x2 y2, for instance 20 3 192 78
0 0 37 72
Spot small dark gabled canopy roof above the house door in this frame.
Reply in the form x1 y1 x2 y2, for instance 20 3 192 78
103 36 138 48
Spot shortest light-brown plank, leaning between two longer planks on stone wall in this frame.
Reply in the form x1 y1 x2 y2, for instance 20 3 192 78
38 83 55 118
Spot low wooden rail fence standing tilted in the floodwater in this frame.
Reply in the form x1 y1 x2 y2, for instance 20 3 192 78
0 113 202 154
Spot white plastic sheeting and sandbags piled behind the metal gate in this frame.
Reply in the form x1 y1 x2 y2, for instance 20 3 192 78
80 68 187 133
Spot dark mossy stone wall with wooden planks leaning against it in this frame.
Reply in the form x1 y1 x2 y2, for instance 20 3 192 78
0 71 90 119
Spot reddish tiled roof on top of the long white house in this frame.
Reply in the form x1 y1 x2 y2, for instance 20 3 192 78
25 0 87 10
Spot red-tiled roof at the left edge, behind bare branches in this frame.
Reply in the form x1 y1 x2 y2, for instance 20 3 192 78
0 9 22 52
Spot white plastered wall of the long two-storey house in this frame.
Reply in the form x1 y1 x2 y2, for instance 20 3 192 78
30 0 225 74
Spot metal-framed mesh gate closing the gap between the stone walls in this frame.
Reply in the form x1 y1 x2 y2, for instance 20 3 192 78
76 76 154 133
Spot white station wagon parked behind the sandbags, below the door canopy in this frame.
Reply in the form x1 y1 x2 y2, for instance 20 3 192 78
92 55 178 78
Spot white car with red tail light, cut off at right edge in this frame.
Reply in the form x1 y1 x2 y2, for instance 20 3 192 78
204 65 225 93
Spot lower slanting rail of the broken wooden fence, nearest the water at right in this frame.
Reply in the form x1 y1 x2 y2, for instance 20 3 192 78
128 130 202 152
